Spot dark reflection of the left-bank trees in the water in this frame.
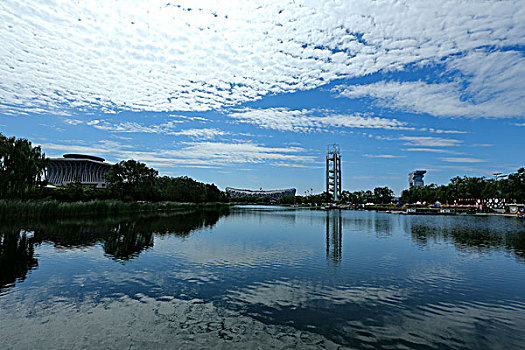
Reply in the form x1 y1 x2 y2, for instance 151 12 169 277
0 208 229 292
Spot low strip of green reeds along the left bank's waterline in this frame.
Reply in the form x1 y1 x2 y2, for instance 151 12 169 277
0 200 229 220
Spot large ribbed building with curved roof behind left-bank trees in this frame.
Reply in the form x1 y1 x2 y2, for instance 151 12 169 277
46 154 111 188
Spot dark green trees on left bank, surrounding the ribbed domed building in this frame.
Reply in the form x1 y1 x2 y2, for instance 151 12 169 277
0 134 228 203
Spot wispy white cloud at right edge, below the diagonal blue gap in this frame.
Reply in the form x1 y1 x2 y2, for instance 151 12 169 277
333 51 525 119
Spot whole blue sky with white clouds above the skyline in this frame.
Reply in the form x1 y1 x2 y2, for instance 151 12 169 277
0 0 525 195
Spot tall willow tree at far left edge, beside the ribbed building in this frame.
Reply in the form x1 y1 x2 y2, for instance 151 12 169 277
0 134 47 198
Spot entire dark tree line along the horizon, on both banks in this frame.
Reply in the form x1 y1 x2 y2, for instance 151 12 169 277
0 134 525 205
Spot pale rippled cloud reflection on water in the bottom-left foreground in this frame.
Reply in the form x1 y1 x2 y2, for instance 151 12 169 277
0 293 348 349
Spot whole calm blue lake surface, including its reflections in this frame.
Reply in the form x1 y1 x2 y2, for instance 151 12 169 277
0 207 525 349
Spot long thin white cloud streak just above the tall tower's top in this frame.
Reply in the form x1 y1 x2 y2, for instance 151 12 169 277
228 108 412 133
